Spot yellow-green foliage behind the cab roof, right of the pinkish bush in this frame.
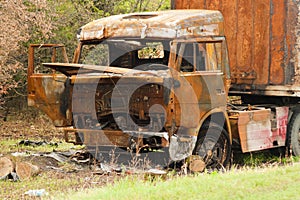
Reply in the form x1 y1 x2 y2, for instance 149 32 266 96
48 0 170 60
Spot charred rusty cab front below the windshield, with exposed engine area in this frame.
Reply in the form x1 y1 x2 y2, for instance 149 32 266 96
67 71 170 148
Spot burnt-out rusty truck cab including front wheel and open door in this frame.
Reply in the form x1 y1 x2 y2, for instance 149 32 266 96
28 10 231 168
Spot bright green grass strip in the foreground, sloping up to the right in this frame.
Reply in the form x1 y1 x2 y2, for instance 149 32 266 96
55 164 300 200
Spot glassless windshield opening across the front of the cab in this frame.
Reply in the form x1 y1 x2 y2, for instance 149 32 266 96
79 38 170 70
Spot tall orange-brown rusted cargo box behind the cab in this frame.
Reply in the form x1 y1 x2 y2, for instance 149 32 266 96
172 0 300 97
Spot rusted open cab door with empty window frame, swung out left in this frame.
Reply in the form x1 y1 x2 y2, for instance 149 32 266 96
27 44 72 127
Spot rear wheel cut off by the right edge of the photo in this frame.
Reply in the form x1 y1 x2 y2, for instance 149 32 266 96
287 112 300 156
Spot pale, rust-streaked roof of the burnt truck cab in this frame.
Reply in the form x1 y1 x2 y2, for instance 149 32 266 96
78 9 224 41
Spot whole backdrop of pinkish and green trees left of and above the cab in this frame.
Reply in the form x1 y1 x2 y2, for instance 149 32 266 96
0 0 170 114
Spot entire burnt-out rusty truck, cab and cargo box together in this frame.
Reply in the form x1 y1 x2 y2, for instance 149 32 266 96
28 0 300 171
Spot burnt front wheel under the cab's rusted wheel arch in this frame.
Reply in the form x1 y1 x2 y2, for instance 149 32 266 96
193 123 231 169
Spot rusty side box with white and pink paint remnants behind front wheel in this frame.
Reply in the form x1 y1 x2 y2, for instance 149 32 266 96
231 107 289 152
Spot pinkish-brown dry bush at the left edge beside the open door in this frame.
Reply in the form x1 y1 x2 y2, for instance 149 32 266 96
0 0 53 106
